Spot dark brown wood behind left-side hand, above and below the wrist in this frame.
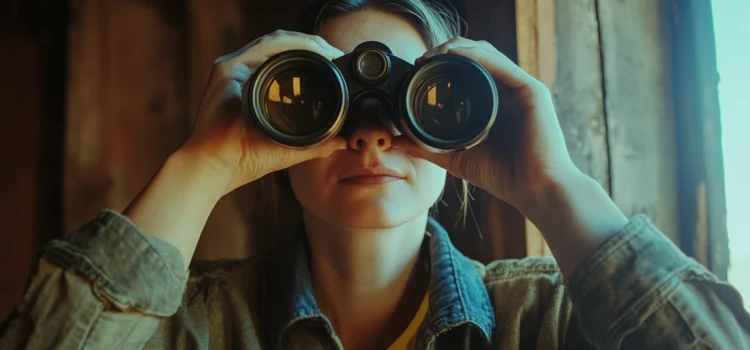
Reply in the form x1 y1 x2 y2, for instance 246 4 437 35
185 0 314 259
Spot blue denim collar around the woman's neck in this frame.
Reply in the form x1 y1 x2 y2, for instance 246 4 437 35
261 218 495 348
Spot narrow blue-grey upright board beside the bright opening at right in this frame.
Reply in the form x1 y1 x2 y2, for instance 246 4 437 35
665 0 728 279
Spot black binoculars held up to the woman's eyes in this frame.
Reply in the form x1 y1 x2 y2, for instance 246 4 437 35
243 41 498 152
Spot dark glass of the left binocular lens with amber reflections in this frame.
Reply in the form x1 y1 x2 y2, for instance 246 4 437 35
263 67 336 136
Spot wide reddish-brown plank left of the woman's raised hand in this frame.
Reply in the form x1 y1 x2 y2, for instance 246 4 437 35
64 0 189 231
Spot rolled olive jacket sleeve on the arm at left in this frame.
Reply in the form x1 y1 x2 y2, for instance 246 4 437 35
0 210 188 349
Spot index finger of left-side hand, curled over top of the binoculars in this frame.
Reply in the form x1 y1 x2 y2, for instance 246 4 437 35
217 31 344 68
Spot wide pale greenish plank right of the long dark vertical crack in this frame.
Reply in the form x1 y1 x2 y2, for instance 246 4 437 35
600 0 678 241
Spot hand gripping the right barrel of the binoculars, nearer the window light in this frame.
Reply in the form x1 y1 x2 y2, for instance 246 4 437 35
393 37 584 212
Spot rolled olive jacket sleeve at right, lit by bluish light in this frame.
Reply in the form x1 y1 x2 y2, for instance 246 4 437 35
567 215 750 349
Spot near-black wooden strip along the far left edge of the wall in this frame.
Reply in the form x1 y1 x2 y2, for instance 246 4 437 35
0 0 67 324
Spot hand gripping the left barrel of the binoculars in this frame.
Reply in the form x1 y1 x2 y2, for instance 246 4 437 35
178 31 347 194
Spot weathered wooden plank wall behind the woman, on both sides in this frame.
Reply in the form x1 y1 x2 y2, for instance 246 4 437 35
0 0 725 322
